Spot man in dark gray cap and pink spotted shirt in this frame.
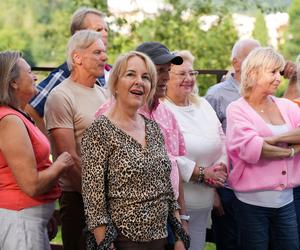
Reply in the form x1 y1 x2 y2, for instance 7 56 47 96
96 42 189 250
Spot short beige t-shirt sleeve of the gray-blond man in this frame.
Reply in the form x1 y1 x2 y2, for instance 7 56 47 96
45 90 74 130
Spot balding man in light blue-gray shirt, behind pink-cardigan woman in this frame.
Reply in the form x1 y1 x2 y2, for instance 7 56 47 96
205 39 260 250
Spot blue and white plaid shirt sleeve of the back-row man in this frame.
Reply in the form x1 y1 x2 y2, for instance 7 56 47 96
29 70 66 117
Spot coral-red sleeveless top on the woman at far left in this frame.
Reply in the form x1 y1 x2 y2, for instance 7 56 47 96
0 106 60 210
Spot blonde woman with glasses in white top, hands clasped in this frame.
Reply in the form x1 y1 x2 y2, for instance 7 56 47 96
164 51 227 250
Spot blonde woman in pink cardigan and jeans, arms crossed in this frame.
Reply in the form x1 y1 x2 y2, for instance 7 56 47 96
227 48 300 250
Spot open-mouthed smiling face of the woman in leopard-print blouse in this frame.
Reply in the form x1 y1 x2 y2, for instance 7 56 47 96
115 56 151 109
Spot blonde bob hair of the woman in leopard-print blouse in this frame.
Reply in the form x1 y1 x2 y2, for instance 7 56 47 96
108 51 157 103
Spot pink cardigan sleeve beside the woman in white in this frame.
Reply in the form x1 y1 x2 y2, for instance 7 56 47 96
226 102 264 164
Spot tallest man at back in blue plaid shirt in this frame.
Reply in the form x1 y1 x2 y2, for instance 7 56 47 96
26 8 111 134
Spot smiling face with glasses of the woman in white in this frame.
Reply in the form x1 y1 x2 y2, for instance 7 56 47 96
168 60 196 98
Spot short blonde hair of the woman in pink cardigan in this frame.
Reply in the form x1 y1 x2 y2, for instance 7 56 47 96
241 47 285 98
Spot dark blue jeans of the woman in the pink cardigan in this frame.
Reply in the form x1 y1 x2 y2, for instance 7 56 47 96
236 200 298 250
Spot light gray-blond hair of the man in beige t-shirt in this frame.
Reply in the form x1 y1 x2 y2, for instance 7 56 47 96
67 30 102 71
